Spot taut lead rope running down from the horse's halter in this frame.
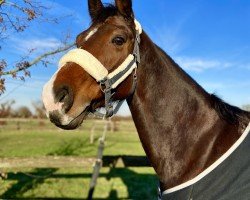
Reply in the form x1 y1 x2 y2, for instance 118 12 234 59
87 119 108 200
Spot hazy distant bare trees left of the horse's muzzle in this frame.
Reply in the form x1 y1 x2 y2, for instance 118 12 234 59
0 101 46 119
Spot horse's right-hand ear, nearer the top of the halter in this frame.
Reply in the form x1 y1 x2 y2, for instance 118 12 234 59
115 0 134 18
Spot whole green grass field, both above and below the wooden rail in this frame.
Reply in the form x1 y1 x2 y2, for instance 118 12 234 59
0 120 157 199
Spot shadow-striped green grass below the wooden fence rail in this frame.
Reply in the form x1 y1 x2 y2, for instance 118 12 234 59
0 168 157 199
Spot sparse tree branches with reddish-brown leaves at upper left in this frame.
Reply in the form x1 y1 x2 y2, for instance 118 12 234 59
0 0 74 95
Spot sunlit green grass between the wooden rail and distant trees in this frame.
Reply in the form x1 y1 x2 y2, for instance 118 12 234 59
0 121 145 157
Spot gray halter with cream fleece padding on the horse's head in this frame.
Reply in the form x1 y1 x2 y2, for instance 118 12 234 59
59 20 142 118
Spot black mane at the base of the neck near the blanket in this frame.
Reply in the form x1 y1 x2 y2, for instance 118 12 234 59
211 94 250 125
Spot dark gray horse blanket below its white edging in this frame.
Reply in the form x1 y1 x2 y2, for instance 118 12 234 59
161 129 250 200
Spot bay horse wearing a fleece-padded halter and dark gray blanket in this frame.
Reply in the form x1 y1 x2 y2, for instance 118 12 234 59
42 0 250 200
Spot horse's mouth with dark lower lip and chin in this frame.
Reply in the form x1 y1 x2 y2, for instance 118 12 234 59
53 106 90 130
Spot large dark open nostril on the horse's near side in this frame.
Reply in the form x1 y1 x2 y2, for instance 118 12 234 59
55 86 73 112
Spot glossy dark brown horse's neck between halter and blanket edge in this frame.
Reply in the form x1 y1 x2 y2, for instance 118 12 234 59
128 34 242 189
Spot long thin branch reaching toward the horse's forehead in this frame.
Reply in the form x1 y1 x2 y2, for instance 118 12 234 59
0 44 75 76
